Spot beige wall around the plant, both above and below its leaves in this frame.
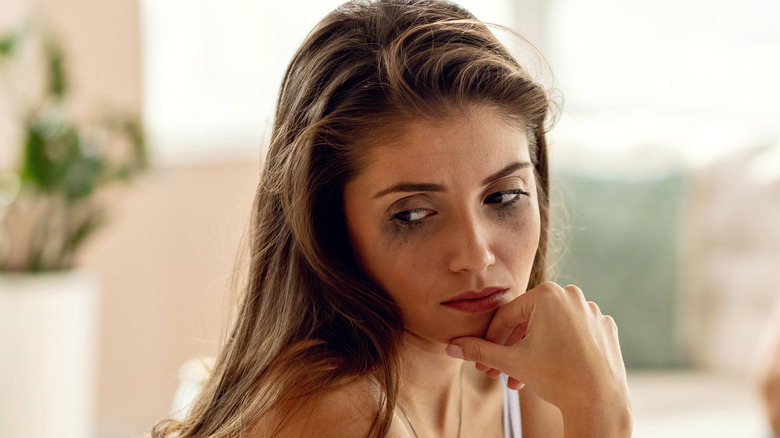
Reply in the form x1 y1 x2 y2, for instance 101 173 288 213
6 0 257 438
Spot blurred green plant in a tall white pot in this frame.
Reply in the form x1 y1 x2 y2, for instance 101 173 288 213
0 27 148 438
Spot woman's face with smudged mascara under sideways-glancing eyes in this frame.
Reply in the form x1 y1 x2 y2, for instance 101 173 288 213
344 108 540 350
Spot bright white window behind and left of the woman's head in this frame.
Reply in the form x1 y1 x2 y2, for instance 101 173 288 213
141 0 514 162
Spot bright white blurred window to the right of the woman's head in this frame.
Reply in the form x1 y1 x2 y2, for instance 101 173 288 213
545 0 780 163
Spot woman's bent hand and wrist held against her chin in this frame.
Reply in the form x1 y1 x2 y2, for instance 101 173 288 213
447 282 631 436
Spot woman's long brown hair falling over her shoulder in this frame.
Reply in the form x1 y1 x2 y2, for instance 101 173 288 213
152 0 550 438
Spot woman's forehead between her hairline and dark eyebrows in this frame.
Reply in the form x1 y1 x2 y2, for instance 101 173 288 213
359 108 531 180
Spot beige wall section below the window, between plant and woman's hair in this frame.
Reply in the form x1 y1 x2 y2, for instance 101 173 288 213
83 162 256 432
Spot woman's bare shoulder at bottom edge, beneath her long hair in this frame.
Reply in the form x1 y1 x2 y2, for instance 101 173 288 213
247 378 408 438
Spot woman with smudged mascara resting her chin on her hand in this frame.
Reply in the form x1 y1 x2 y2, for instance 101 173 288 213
153 0 631 437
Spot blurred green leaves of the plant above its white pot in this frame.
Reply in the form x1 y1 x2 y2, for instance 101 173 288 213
0 25 149 272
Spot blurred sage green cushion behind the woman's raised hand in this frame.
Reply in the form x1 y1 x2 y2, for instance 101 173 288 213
551 169 687 368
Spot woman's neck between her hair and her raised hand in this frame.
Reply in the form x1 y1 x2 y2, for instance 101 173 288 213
399 333 464 436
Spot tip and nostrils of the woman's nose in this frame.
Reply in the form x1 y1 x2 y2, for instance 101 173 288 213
448 213 496 273
